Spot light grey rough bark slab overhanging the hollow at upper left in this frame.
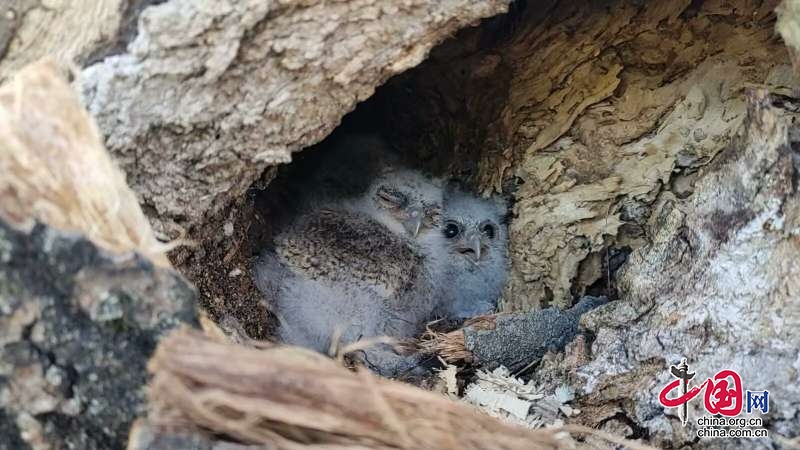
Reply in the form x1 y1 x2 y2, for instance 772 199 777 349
82 0 508 236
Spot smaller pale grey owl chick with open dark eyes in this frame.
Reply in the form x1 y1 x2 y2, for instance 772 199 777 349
436 185 508 319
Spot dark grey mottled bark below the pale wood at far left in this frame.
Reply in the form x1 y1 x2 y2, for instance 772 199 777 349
0 221 196 450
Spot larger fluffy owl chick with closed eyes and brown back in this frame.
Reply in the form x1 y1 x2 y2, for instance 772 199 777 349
254 170 444 376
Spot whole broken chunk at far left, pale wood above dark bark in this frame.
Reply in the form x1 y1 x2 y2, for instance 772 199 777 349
0 64 196 450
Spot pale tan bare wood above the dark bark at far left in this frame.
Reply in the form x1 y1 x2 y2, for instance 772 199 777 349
0 60 170 267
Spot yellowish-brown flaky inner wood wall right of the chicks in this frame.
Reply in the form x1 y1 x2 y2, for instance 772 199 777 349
504 0 785 310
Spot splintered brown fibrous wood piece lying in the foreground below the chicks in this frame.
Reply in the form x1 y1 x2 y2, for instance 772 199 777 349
141 330 567 450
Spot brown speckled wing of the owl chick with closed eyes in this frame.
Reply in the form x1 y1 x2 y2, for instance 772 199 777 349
275 209 423 298
